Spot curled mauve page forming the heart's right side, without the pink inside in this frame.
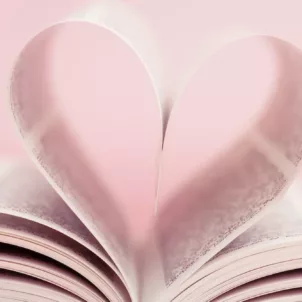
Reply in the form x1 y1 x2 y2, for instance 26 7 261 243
151 38 302 302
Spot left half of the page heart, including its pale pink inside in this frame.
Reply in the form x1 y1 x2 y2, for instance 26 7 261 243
10 1 162 299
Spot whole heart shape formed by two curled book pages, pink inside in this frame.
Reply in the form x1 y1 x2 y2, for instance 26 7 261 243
10 22 302 285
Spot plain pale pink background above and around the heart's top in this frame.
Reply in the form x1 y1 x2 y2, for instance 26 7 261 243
0 0 302 157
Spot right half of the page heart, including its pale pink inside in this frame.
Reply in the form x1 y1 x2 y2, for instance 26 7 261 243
156 36 302 286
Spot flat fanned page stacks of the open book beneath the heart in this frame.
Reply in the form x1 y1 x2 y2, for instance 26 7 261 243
0 163 302 302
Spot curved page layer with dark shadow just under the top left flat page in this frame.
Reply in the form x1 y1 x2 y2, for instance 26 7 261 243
0 214 129 301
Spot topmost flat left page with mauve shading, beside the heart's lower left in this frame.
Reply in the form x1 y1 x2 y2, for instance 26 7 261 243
0 162 120 275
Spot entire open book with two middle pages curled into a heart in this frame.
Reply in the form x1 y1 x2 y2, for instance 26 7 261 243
4 3 302 302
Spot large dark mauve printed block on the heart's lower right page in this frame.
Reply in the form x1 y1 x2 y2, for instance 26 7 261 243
156 142 286 286
